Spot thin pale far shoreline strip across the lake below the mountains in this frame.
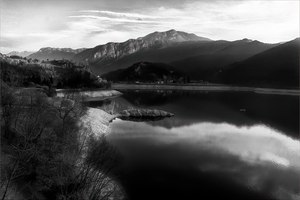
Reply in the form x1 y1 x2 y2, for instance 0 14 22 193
111 84 300 96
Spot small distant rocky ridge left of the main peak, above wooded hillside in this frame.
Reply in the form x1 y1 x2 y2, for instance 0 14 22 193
27 47 85 60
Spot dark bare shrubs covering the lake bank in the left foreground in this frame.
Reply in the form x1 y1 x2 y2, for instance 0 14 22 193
0 87 122 200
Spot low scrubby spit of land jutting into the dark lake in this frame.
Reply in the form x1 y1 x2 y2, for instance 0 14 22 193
117 109 174 121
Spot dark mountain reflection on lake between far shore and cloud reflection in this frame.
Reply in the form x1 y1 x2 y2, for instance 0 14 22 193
114 91 299 137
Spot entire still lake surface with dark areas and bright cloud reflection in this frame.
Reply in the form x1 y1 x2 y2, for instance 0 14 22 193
86 91 300 200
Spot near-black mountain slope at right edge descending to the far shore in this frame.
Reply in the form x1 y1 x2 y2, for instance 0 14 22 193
218 38 300 88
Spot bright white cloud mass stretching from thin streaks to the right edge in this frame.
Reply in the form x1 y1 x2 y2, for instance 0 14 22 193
67 1 298 43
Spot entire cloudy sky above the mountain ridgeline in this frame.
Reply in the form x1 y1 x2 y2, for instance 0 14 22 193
0 0 299 53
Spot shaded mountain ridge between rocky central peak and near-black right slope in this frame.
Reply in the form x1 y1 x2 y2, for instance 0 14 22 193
170 39 278 82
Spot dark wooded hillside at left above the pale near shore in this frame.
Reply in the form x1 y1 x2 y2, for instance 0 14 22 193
0 54 108 88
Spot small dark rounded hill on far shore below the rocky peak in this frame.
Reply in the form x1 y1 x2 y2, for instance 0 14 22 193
103 62 187 83
